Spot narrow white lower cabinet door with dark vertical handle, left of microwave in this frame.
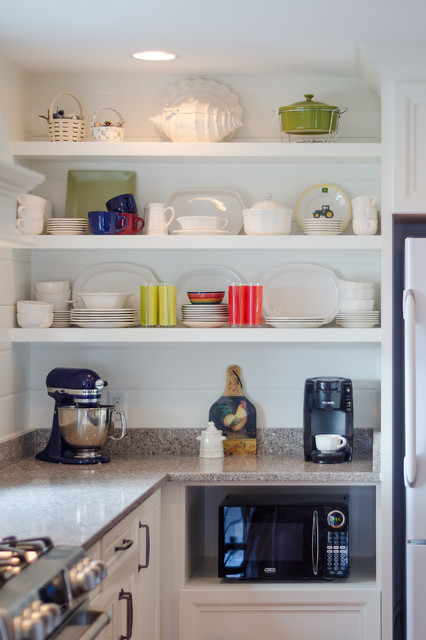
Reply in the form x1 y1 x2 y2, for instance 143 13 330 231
136 490 161 640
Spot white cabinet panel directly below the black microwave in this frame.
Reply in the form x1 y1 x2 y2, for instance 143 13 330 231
179 589 380 640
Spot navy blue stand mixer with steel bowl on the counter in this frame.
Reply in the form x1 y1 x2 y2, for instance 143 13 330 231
36 367 127 464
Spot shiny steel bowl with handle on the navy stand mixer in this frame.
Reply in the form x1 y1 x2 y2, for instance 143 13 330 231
58 405 127 458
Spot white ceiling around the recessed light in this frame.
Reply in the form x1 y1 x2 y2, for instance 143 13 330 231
0 0 426 76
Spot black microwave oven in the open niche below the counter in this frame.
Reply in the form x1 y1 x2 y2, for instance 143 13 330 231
218 495 349 580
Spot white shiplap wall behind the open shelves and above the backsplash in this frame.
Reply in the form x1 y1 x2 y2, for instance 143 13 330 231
0 55 380 438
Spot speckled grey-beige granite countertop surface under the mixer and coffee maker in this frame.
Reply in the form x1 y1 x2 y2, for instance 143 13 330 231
0 455 380 549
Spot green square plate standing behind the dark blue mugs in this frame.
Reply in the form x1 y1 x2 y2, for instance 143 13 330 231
65 171 136 218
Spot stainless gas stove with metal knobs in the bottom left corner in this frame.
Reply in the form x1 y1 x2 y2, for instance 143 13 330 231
0 537 108 640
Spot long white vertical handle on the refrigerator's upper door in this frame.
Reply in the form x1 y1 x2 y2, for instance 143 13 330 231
403 289 416 487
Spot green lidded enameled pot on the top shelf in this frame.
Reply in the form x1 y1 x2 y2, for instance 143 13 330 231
278 93 347 135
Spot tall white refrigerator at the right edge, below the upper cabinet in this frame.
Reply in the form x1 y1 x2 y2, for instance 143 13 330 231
393 215 426 640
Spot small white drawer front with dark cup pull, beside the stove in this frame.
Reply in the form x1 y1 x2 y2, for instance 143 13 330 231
101 513 138 574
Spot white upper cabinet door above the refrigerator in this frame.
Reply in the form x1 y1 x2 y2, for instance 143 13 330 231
392 82 426 213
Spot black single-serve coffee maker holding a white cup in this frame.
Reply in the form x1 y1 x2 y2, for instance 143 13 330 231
303 377 354 464
